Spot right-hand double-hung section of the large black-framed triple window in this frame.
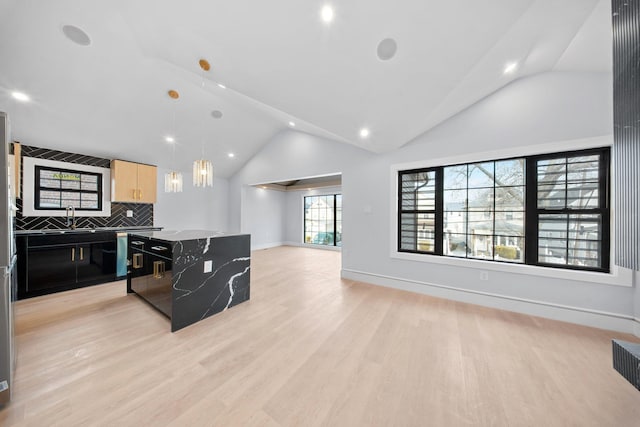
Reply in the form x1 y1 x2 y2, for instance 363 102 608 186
530 150 610 270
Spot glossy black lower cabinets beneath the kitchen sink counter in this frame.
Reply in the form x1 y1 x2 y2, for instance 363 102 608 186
17 233 116 299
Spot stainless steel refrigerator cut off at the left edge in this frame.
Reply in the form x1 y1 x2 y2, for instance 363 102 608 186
0 111 17 406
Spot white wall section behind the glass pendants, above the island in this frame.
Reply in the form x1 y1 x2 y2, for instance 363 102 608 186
153 168 229 231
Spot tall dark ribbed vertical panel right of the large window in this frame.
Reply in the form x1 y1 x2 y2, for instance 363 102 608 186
611 0 640 270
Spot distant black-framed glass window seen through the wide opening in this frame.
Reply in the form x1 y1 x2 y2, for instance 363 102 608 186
304 194 342 246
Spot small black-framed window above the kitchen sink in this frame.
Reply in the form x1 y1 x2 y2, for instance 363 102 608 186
34 166 102 211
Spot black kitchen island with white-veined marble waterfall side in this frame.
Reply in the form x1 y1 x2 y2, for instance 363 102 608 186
127 230 251 332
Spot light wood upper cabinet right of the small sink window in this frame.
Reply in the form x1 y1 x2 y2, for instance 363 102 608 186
111 160 158 203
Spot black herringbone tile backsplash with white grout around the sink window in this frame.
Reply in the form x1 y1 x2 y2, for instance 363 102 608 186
16 145 153 230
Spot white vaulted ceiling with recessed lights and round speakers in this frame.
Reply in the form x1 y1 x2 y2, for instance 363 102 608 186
0 0 611 177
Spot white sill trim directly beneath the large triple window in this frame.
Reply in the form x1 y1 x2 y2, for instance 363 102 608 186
391 250 633 287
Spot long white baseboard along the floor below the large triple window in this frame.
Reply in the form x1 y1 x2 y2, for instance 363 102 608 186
341 269 640 337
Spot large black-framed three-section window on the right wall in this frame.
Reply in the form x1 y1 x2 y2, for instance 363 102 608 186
397 148 610 271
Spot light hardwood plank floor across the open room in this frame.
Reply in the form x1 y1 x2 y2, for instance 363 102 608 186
0 247 640 427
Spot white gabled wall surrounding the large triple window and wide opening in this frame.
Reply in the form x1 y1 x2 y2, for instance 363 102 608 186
230 72 640 332
